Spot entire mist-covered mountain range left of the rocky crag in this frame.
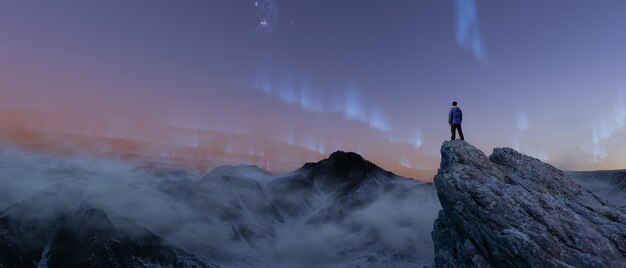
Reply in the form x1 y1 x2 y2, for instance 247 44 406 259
0 149 440 267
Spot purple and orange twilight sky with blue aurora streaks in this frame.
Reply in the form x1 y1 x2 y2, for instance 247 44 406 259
0 0 626 181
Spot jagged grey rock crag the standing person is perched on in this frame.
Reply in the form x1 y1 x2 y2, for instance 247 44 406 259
432 141 626 267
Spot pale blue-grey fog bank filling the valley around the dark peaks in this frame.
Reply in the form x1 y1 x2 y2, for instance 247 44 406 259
0 147 440 267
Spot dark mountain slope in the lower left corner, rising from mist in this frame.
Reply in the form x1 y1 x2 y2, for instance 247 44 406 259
0 189 216 267
